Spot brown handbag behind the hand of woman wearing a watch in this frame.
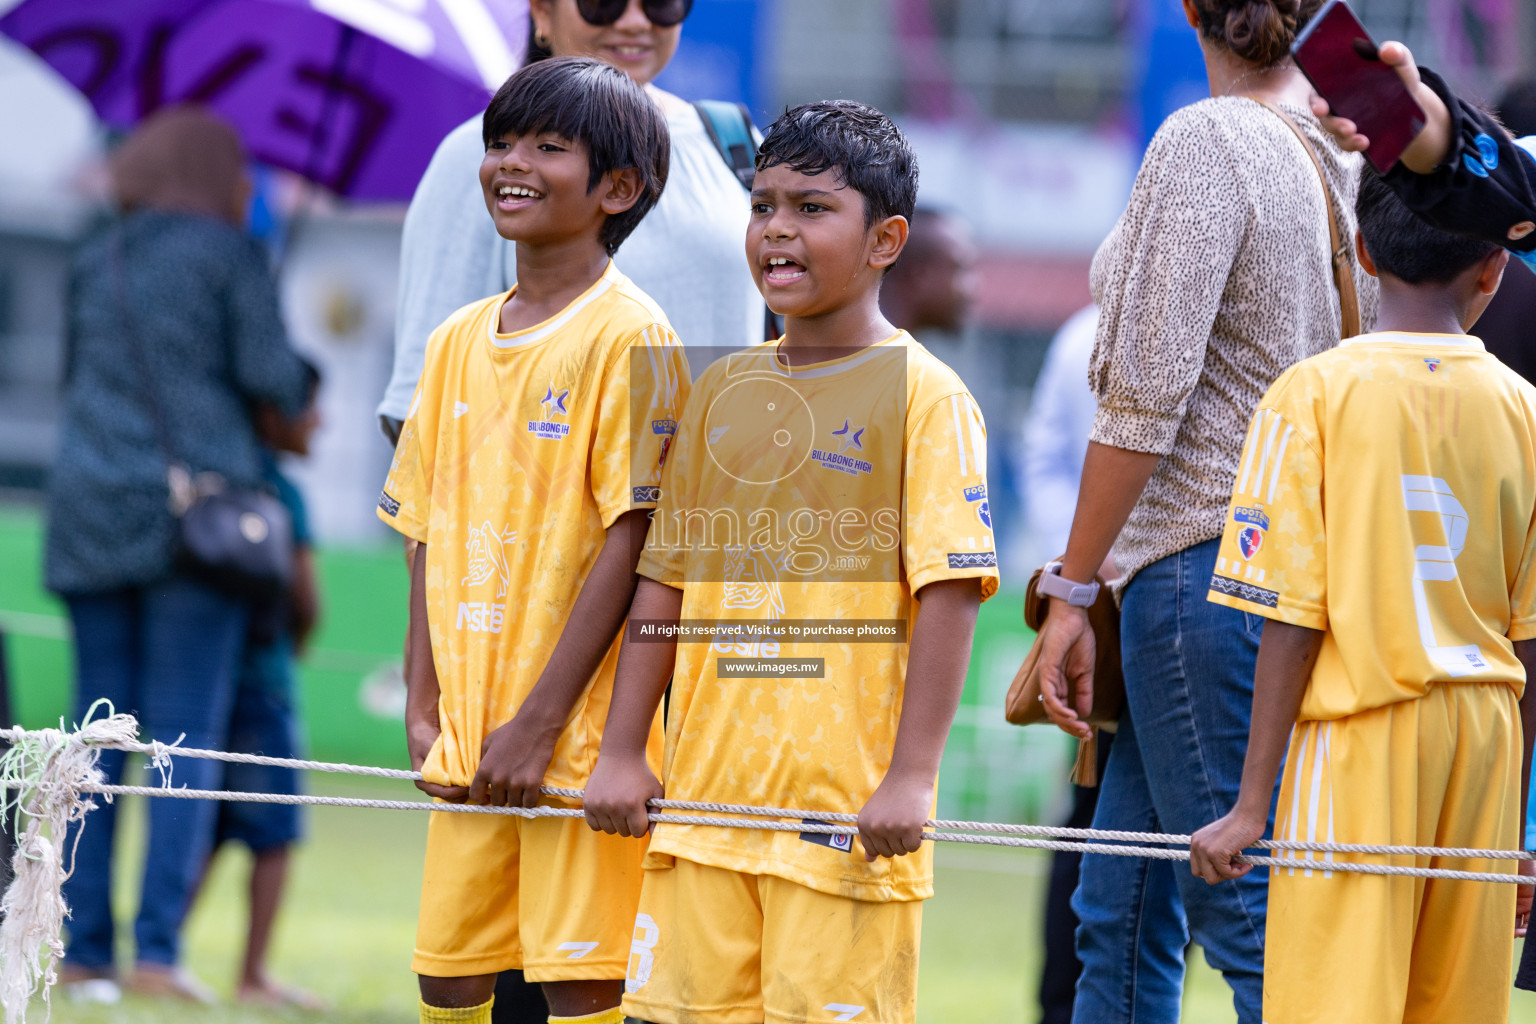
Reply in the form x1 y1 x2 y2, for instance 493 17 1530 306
1003 568 1126 786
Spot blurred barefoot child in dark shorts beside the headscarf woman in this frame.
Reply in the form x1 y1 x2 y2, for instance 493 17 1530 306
195 379 324 1010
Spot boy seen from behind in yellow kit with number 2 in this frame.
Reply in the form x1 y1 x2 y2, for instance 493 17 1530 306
1192 175 1536 1024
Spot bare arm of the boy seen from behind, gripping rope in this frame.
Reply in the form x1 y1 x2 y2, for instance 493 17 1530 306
1189 619 1322 884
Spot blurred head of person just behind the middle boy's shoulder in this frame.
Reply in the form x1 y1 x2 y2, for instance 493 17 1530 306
884 207 977 334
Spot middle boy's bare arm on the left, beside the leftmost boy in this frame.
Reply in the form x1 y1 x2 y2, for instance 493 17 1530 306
582 579 682 835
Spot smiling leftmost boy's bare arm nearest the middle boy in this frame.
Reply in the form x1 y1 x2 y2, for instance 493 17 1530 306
468 508 650 808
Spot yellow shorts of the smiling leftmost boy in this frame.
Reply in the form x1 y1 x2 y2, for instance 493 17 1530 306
410 812 645 981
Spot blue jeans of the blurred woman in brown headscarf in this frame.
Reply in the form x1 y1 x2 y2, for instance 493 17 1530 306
65 579 247 970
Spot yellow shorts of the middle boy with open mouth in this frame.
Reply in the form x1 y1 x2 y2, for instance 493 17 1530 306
624 858 923 1024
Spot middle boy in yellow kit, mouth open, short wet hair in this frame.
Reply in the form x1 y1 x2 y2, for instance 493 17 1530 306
585 101 997 1024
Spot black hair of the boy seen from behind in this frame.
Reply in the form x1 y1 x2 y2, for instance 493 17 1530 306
1355 172 1498 284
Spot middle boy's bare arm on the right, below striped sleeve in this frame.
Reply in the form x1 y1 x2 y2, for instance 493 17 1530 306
859 579 982 861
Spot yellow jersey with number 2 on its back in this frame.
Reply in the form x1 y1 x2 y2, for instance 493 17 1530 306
1210 333 1536 720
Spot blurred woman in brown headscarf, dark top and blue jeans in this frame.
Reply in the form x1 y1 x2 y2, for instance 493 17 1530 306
45 107 309 999
